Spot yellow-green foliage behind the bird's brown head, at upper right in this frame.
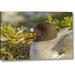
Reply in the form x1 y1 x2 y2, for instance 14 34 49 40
48 13 73 28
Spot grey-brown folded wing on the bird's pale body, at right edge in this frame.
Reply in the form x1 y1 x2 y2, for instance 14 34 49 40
53 29 73 58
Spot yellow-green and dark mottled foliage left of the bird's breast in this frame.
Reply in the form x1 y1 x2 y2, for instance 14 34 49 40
0 24 32 60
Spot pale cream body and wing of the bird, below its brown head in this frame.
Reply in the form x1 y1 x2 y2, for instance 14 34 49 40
30 22 72 60
